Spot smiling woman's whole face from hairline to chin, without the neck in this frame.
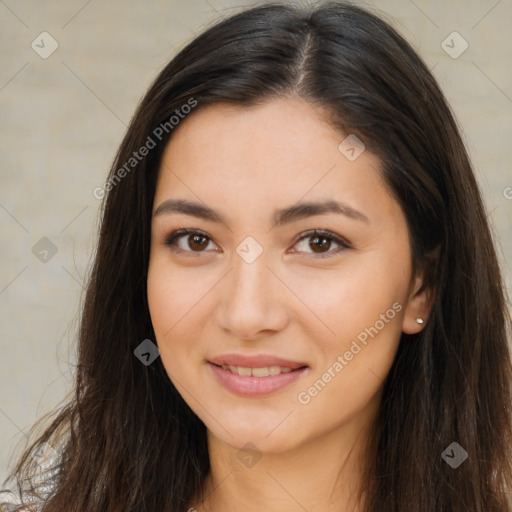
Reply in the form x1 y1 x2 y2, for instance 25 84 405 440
148 98 424 452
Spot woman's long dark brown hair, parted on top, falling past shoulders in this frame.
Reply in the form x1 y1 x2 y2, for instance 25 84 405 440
5 3 512 512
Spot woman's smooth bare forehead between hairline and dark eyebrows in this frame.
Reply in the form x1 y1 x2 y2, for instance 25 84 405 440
155 98 396 225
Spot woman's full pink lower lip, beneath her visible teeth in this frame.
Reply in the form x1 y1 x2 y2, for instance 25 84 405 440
208 363 307 396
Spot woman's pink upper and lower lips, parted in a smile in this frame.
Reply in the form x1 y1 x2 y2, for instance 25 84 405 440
208 354 309 397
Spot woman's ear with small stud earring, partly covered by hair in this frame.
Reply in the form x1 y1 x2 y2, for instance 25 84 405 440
402 247 439 334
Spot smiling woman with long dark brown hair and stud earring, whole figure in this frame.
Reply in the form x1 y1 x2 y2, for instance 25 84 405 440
2 4 512 512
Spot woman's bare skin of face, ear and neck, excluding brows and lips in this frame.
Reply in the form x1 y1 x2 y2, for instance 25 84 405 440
148 97 430 512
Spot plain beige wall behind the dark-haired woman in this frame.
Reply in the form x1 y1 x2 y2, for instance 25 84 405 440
0 0 512 480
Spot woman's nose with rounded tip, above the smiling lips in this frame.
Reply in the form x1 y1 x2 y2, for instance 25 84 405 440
216 252 289 340
